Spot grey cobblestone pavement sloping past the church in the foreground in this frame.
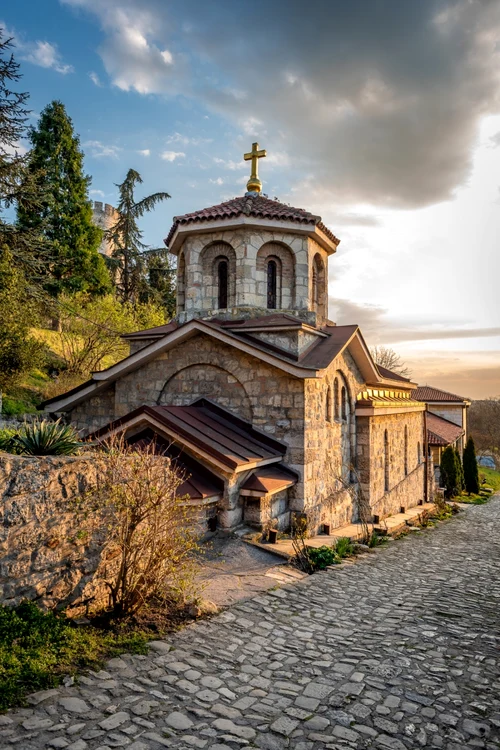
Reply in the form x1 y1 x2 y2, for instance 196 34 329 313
0 498 500 750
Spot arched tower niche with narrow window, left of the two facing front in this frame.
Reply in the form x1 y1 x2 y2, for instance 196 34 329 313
200 242 236 310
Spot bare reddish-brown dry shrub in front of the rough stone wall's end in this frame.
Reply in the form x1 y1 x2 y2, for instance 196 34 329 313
79 439 199 617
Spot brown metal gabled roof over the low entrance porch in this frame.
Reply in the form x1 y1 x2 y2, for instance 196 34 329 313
89 399 286 471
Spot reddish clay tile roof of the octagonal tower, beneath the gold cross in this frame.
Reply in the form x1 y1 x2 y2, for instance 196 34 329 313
165 195 340 247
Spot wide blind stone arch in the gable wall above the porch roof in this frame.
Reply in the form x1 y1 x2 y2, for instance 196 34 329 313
157 362 252 422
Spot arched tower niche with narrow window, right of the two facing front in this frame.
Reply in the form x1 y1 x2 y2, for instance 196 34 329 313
256 242 295 310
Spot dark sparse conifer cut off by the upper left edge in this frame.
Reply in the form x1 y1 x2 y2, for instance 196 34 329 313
0 28 48 284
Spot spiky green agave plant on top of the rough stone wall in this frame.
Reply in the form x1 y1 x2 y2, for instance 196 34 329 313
15 419 83 456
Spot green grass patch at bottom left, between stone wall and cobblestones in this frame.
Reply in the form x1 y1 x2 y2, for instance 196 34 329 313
0 602 183 711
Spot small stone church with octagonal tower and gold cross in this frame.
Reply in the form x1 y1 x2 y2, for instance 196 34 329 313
44 144 429 533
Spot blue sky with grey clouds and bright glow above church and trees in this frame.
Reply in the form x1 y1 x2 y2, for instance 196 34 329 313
0 0 500 398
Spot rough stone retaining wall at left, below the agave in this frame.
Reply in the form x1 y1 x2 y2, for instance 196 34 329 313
0 455 103 607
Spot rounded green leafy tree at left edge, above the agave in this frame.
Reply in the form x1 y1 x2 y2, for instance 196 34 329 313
0 247 42 394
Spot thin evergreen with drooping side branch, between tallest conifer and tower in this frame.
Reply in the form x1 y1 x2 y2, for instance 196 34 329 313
107 169 170 302
